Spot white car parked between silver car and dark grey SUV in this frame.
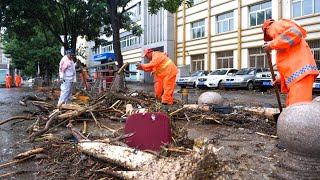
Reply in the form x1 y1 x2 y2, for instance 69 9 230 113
196 68 238 88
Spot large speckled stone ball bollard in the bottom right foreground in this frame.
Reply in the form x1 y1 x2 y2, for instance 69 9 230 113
277 102 320 179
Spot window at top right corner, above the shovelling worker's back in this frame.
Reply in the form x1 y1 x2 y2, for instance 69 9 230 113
292 0 320 17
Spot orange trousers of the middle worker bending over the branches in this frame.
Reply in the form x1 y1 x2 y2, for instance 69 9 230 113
154 75 176 105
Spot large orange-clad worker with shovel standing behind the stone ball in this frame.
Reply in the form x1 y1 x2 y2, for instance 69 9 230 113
262 19 319 106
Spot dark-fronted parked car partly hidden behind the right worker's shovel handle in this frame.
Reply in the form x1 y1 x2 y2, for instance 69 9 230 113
253 69 280 92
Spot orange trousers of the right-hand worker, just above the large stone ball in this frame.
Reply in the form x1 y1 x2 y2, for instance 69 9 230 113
286 75 314 107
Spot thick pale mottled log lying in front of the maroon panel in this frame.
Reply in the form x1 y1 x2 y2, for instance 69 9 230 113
78 141 157 170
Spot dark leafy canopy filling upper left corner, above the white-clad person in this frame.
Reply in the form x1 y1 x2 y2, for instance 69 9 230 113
0 0 110 50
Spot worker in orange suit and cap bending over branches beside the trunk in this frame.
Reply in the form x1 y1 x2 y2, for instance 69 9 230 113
136 48 179 110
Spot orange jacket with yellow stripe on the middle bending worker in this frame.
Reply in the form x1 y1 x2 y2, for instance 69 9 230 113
142 51 179 78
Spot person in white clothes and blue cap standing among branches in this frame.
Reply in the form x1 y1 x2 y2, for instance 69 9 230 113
58 49 76 106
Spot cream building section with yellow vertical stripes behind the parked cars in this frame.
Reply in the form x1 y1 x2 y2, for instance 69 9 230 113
175 0 320 71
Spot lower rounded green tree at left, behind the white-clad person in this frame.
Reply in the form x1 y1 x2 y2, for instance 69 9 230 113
3 27 62 79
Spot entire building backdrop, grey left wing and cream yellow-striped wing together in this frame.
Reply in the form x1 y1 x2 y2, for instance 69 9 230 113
88 0 320 82
